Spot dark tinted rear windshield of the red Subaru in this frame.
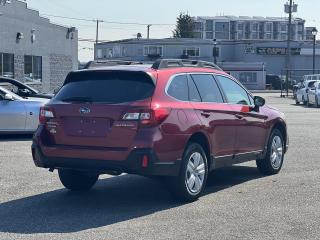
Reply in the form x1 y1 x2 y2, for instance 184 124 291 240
55 71 155 104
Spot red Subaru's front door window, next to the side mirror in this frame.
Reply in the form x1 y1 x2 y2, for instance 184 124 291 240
216 75 251 105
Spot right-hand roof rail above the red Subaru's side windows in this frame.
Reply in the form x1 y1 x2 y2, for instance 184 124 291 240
152 59 222 71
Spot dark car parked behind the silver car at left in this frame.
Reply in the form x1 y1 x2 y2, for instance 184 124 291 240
0 77 53 99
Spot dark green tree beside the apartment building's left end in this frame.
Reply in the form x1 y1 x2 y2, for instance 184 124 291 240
173 12 195 38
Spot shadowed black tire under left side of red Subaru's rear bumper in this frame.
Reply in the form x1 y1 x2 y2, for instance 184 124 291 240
58 169 99 191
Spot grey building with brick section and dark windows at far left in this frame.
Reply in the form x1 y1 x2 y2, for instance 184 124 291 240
0 0 78 91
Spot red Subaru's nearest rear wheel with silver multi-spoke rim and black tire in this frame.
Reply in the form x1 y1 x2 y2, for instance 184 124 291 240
169 143 208 202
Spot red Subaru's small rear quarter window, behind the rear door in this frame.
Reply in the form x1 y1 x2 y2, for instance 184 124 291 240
167 74 189 101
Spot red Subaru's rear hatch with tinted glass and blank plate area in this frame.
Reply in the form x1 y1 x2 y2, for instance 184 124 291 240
42 70 155 148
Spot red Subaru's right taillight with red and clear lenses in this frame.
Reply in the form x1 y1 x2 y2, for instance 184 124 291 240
122 108 170 126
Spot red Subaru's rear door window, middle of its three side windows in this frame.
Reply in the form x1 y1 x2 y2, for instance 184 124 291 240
191 74 223 103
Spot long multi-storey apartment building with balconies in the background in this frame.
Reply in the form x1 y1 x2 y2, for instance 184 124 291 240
194 16 305 41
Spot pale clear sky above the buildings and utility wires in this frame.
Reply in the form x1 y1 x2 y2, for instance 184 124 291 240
27 0 320 60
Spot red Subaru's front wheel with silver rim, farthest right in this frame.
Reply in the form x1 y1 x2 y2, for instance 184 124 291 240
256 129 285 175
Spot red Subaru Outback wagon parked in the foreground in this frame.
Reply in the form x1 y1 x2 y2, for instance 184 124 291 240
32 60 288 201
